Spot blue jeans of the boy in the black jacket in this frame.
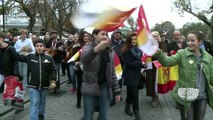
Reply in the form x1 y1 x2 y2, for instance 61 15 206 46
29 88 48 120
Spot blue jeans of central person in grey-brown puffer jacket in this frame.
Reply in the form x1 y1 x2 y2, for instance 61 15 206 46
82 85 111 120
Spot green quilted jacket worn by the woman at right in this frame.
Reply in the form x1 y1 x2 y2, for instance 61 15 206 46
154 48 213 109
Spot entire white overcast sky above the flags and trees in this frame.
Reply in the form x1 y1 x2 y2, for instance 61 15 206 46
83 0 211 32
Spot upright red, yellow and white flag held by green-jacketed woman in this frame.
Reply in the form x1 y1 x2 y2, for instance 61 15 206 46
137 5 158 56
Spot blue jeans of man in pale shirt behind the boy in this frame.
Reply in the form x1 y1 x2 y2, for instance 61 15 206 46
18 62 27 91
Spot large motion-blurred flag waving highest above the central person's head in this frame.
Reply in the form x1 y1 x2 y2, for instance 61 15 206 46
71 0 138 32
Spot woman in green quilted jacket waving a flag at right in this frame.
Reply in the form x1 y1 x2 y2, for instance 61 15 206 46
155 32 213 120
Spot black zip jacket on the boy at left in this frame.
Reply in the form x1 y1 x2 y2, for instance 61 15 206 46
17 54 58 90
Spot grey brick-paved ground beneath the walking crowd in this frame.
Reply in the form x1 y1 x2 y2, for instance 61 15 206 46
0 77 213 120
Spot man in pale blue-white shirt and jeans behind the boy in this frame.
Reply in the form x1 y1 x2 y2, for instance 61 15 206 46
14 30 35 91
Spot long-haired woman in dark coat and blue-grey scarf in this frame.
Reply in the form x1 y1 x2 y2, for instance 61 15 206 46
122 33 146 120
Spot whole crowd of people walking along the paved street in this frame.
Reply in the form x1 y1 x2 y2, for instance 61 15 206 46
0 29 213 120
